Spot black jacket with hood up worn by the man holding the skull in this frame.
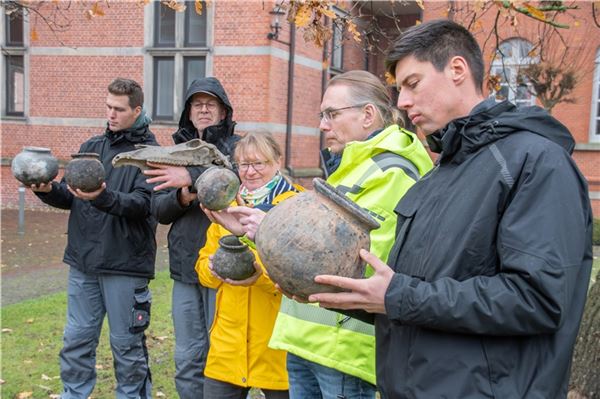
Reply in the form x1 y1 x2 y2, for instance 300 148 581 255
152 77 240 284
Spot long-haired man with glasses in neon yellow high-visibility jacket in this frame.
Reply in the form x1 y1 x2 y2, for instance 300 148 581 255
206 71 432 399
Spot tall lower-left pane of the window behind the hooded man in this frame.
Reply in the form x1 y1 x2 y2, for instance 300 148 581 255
153 57 175 120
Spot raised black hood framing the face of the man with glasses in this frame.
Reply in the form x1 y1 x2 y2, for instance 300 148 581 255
173 77 235 144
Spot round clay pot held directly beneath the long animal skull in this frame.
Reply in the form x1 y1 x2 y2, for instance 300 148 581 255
194 166 240 211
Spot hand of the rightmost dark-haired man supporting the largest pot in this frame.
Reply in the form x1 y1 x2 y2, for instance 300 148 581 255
308 249 394 314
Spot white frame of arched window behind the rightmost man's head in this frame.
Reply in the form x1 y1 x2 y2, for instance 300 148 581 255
490 38 537 106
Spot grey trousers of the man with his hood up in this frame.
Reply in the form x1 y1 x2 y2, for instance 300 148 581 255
172 280 216 399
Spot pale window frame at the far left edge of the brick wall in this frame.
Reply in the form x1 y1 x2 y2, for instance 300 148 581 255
0 7 29 120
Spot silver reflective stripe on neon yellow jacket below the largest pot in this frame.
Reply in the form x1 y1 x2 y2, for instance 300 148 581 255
279 300 375 335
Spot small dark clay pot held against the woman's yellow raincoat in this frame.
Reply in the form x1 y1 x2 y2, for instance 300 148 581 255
212 235 256 280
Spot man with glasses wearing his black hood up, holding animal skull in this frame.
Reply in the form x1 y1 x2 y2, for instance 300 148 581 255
144 77 239 399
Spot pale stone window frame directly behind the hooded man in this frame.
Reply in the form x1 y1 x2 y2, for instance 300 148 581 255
144 1 215 124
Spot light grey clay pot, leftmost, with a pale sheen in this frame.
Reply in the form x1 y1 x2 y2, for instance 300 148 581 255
11 147 58 187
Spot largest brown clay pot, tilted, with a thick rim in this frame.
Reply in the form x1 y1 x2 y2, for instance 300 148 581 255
255 179 379 298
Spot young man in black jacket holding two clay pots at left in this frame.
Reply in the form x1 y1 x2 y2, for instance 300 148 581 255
31 78 157 399
